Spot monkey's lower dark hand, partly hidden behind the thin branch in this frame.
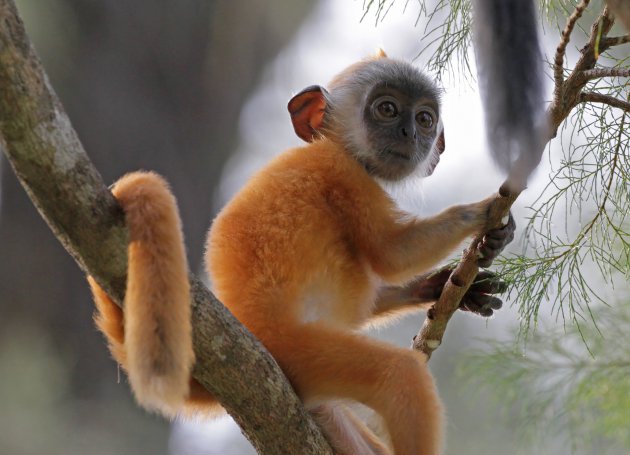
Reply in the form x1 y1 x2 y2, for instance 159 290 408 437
409 267 507 317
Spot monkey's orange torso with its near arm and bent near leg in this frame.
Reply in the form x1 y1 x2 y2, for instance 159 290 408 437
206 139 488 455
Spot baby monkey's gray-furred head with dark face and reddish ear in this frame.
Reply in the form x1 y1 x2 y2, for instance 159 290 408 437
289 53 444 181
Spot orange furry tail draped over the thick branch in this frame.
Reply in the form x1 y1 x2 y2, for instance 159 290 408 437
89 172 196 416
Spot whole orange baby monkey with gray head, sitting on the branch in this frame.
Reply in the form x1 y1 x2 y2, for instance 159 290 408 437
91 52 513 455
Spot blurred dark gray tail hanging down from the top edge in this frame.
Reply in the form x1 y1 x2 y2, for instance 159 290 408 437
473 0 549 190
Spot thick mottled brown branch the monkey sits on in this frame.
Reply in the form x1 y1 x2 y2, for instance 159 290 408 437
0 0 331 455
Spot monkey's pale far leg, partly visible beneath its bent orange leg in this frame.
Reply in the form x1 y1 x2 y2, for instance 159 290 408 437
309 402 390 455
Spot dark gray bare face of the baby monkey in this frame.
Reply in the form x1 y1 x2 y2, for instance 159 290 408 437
360 84 439 180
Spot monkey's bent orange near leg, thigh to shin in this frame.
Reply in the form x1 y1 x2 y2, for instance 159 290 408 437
262 323 442 455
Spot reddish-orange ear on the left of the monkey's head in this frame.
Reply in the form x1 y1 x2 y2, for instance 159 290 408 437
287 85 326 142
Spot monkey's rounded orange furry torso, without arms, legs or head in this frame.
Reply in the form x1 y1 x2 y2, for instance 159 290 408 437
206 139 393 336
